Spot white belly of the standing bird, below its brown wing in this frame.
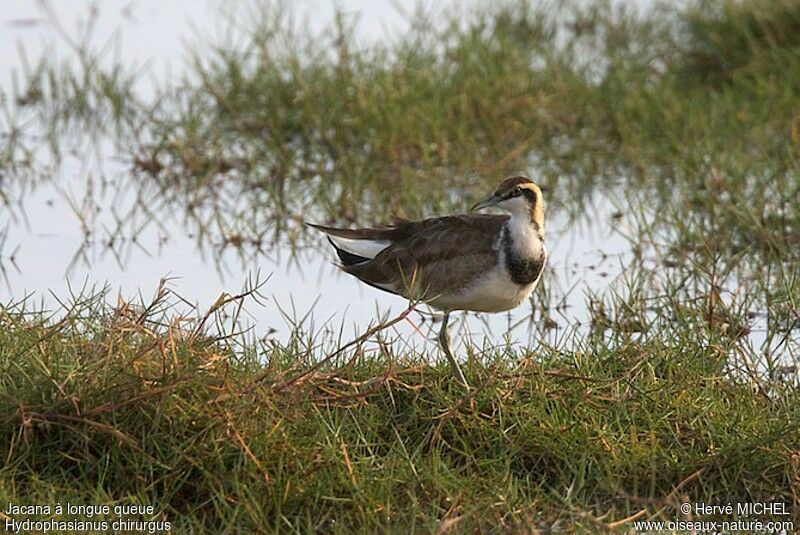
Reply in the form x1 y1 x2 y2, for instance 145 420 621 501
430 265 539 312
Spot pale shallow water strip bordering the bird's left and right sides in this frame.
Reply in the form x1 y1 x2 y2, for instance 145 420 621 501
0 134 630 352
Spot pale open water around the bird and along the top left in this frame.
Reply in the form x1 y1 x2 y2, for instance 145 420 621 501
0 0 652 358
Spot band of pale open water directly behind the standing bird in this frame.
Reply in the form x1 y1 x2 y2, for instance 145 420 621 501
4 119 630 350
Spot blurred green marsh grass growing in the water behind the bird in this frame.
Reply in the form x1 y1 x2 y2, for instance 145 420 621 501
7 0 800 268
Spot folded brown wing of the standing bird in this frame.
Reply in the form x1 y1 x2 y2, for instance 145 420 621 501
343 214 508 299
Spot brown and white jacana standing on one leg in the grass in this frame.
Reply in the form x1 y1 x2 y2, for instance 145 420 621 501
308 176 547 391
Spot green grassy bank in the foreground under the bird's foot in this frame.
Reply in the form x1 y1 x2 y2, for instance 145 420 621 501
0 284 800 532
